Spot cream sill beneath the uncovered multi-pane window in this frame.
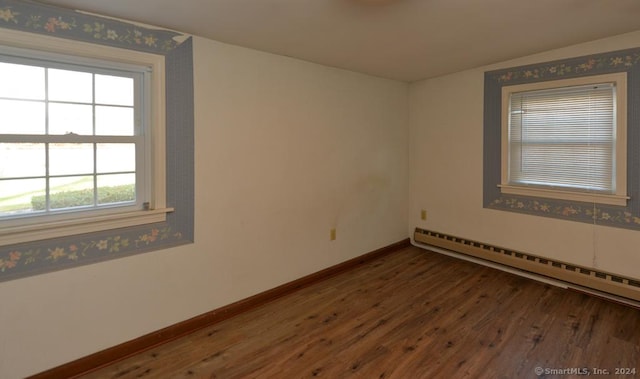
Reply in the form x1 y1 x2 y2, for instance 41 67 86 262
0 208 173 246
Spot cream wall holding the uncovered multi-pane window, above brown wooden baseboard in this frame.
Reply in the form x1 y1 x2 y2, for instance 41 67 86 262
0 38 409 378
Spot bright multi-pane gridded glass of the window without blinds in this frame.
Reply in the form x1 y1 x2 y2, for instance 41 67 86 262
0 55 145 219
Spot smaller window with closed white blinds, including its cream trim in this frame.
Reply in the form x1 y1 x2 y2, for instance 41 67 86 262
500 73 628 205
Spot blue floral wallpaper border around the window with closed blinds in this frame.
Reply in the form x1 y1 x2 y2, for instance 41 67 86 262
483 48 640 230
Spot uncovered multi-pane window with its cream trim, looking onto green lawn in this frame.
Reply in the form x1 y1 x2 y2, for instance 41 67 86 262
0 30 171 245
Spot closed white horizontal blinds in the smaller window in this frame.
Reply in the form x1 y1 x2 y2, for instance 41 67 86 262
509 83 616 193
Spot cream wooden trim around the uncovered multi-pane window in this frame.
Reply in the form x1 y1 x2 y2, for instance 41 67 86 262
0 29 173 246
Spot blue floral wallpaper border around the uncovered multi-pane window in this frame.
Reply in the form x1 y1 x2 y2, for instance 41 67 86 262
0 0 194 282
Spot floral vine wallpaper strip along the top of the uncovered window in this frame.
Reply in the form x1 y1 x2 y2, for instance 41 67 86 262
0 0 180 53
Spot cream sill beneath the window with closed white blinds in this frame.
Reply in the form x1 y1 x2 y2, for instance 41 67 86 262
498 184 630 207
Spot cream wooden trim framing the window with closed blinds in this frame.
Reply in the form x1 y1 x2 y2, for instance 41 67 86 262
498 72 629 206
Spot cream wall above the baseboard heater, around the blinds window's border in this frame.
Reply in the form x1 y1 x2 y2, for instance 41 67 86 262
408 32 640 278
